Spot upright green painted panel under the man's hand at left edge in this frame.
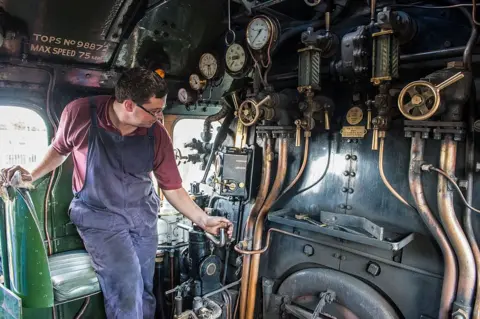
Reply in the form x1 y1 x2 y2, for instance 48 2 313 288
5 187 53 308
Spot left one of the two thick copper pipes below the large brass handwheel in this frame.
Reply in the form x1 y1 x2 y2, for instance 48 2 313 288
408 133 457 319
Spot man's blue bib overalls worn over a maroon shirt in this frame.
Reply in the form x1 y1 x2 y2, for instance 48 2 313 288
70 99 160 319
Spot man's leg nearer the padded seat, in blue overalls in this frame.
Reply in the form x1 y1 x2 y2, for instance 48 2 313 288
77 227 144 319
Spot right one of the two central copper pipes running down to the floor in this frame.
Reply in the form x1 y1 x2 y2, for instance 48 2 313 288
246 138 288 319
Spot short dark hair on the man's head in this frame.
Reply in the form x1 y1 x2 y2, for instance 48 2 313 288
115 68 168 104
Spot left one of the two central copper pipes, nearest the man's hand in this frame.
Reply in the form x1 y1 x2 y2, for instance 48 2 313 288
237 136 273 319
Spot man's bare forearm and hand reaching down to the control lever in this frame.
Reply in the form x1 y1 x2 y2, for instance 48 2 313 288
162 188 233 237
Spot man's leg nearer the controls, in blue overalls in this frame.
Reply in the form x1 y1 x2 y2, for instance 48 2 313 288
130 227 158 319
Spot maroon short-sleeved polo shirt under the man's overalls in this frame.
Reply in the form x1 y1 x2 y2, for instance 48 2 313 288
52 95 182 192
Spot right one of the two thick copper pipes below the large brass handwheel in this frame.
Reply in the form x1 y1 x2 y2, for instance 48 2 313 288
437 135 476 312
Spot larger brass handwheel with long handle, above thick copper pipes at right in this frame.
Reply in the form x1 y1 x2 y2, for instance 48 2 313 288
398 72 464 121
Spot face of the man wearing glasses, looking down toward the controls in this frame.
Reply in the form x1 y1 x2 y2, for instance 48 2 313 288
124 96 167 128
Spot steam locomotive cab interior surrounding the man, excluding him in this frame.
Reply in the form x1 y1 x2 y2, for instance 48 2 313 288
0 0 480 319
